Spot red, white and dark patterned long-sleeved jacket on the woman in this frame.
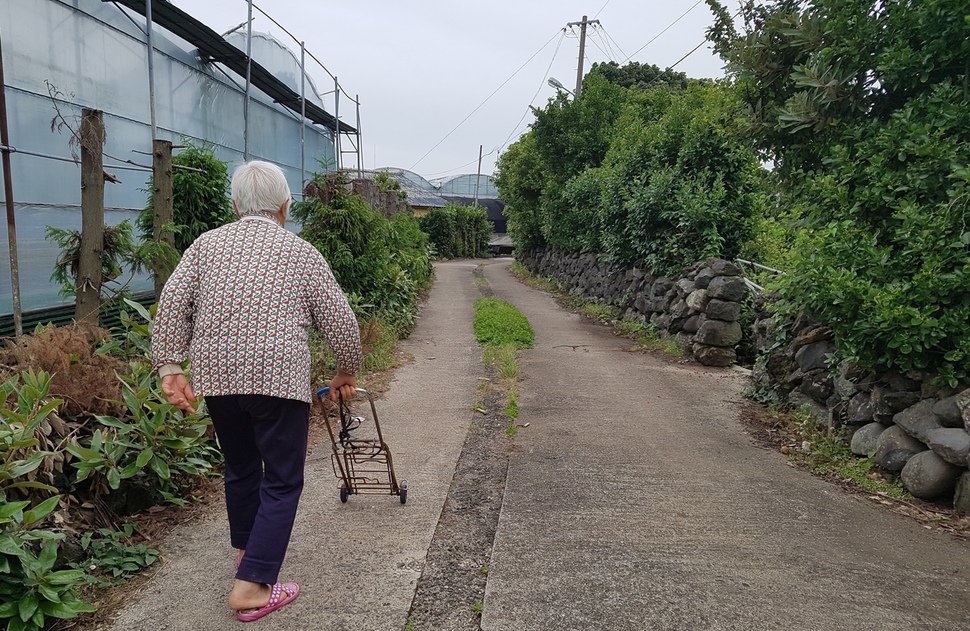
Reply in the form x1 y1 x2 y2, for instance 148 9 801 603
152 216 362 402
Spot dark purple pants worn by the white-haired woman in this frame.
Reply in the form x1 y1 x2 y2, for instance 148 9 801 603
205 394 310 585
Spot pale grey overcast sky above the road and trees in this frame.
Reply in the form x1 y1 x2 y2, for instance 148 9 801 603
171 0 737 179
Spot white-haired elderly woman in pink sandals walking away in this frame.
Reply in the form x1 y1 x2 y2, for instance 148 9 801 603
152 161 362 621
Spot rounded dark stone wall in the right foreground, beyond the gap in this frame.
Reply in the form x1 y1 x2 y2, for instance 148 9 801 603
752 296 970 515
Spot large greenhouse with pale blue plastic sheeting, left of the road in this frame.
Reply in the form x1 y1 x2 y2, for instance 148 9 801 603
0 0 360 314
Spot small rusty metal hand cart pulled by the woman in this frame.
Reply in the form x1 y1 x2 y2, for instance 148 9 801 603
317 387 408 504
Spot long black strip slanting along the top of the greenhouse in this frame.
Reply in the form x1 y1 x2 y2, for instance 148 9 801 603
101 0 357 134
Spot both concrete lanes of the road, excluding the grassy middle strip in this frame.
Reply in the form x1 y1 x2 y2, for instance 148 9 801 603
112 260 970 631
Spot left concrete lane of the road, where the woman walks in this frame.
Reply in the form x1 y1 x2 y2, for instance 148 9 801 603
112 262 482 631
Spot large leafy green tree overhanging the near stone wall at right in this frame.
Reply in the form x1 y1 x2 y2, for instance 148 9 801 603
709 0 970 386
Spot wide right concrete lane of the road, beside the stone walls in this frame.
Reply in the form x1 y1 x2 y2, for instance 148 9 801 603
474 263 970 631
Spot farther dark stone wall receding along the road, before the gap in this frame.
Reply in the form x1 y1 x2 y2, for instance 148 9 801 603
516 249 747 366
